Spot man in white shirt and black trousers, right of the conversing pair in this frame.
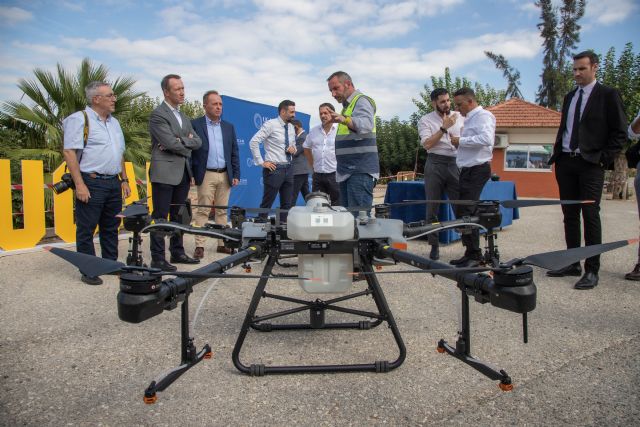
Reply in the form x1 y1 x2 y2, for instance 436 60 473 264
450 87 496 267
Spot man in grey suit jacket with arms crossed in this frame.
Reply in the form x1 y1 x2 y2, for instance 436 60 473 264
149 74 202 271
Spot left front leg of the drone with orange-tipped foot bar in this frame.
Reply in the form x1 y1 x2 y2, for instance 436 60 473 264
143 289 213 404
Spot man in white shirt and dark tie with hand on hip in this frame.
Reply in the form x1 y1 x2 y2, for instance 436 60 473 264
249 99 296 222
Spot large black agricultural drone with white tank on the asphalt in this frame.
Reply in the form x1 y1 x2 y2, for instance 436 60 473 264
50 193 633 403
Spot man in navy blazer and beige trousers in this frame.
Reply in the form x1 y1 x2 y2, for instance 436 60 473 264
191 90 240 259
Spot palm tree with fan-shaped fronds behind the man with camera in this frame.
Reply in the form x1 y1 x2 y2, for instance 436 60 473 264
0 58 149 172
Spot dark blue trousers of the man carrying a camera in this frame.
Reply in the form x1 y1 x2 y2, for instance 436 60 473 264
76 173 122 260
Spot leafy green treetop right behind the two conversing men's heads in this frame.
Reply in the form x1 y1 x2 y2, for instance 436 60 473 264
411 67 507 123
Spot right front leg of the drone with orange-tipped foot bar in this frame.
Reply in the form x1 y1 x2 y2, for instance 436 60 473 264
436 287 513 391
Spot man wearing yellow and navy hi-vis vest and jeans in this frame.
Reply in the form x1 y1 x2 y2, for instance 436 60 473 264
327 71 380 215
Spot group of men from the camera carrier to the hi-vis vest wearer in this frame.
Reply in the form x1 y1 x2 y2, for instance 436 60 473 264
63 71 379 285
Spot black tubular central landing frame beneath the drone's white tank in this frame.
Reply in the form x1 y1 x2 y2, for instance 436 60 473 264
232 254 406 376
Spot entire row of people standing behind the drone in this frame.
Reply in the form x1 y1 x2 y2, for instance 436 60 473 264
64 51 640 289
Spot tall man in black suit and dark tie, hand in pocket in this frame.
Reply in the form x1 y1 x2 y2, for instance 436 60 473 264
547 51 626 289
